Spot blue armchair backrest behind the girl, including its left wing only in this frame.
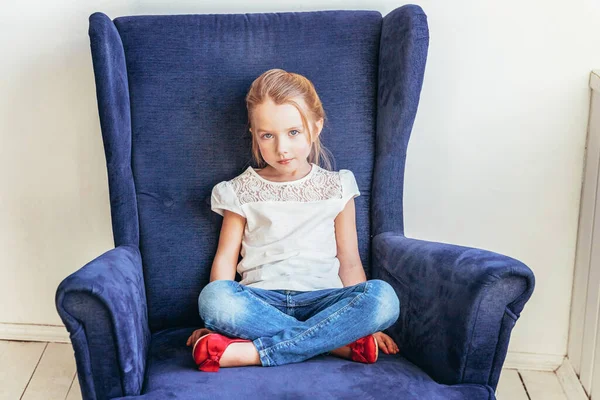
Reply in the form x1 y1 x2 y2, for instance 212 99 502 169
89 11 426 332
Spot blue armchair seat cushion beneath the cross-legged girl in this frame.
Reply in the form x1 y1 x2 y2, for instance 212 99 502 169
113 328 495 400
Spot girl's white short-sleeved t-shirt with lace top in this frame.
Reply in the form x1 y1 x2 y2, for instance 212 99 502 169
211 163 360 291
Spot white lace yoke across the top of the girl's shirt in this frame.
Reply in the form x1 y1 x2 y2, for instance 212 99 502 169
230 165 343 204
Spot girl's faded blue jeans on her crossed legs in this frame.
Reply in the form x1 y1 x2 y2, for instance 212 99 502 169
198 279 400 367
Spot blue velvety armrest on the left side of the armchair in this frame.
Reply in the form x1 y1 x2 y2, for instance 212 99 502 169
55 245 150 399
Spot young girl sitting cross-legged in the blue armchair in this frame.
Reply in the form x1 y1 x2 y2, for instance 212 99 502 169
187 69 400 371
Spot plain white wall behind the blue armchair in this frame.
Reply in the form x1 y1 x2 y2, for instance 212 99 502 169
0 0 600 366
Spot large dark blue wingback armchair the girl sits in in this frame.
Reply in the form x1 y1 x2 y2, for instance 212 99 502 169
56 5 534 400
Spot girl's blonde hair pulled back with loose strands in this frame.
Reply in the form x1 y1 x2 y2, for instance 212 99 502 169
246 68 332 170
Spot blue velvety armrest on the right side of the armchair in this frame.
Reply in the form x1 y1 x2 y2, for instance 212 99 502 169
372 232 535 389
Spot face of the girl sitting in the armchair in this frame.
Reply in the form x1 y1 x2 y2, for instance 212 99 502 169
251 97 323 175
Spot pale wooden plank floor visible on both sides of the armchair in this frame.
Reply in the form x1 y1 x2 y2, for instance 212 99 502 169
0 341 567 400
